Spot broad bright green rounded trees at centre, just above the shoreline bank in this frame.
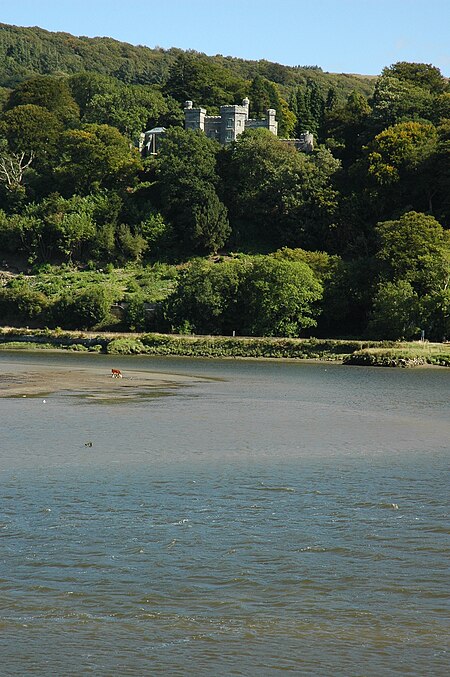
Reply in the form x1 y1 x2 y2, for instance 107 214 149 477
165 256 322 336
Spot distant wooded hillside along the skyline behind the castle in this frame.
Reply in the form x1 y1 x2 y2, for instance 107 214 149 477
0 24 374 100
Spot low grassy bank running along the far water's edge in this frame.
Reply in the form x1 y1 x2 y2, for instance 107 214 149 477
0 328 450 367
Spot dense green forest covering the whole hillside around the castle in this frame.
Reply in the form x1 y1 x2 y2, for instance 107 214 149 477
0 24 450 340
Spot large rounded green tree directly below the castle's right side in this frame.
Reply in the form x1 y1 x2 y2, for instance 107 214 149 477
222 129 339 249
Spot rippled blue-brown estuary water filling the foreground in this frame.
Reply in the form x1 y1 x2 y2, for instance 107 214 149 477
0 353 450 677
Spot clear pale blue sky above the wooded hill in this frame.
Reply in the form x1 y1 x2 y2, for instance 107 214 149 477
0 0 450 76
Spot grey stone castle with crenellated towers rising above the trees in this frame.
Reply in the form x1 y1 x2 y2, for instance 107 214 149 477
184 99 278 144
